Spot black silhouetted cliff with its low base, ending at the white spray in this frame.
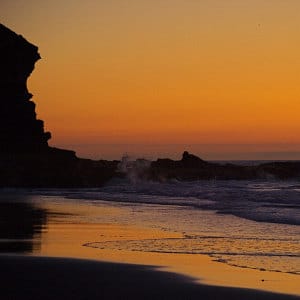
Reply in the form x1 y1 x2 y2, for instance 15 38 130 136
0 24 117 187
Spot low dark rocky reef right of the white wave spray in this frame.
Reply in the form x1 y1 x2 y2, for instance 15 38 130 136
149 151 300 181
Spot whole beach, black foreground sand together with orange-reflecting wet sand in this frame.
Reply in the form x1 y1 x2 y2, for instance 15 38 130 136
0 196 300 300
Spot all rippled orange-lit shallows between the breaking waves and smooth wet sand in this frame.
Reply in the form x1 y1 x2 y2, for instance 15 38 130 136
82 198 300 274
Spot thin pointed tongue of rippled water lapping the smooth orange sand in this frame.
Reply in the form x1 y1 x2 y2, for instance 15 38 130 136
84 236 300 275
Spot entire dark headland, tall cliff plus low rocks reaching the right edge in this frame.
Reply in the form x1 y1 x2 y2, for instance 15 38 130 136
0 24 300 187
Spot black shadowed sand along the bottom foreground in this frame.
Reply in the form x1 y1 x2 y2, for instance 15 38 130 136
0 255 300 300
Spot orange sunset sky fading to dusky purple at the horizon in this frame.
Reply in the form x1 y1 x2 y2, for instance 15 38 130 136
0 0 300 159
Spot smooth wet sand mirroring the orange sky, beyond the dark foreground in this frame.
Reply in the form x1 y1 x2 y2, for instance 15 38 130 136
34 200 300 295
